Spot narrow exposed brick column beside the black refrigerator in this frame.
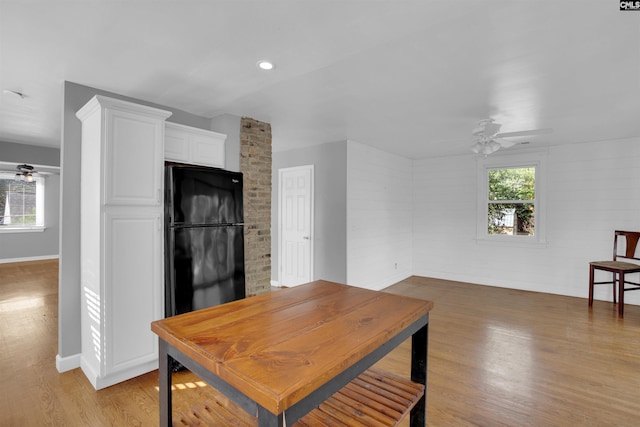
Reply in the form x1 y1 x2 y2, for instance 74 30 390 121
240 117 271 296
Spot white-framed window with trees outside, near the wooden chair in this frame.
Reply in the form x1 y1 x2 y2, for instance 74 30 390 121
478 153 545 243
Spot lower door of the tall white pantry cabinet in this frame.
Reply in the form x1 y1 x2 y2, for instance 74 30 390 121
104 214 163 372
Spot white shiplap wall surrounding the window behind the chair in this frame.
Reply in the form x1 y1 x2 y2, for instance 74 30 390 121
413 138 640 304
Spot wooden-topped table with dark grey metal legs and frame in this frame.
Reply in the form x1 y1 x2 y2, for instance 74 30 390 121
151 281 433 427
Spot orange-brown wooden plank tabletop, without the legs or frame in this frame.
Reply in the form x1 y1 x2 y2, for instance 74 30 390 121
151 281 433 414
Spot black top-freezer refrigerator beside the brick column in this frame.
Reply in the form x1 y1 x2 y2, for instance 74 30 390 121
165 164 245 317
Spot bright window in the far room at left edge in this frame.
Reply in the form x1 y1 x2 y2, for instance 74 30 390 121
0 172 44 232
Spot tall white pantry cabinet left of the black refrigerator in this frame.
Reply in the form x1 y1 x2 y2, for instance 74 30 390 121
77 96 171 389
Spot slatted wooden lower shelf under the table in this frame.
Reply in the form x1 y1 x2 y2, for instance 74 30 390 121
173 368 424 427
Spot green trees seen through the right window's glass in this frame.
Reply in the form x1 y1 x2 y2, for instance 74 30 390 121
487 166 536 236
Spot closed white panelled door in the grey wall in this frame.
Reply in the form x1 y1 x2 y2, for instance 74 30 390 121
278 165 313 286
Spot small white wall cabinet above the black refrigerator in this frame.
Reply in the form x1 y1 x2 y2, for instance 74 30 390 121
164 122 227 168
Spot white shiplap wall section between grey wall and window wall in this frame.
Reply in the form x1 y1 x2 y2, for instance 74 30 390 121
347 141 413 290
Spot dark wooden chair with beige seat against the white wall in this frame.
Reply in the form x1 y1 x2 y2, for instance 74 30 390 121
589 230 640 316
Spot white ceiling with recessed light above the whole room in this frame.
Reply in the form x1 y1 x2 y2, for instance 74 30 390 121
0 0 640 158
